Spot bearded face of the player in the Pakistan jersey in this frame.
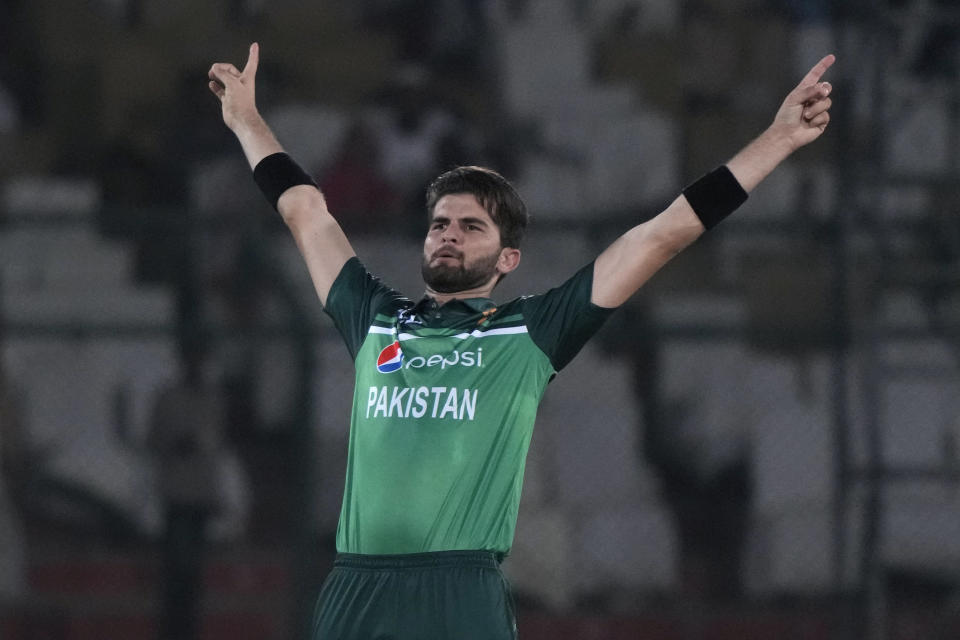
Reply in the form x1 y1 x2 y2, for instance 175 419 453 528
421 193 510 293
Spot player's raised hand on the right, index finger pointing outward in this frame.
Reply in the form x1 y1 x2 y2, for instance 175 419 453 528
770 54 836 149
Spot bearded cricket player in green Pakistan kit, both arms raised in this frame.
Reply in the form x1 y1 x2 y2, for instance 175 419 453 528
209 44 834 640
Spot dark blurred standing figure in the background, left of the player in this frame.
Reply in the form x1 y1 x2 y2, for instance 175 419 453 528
148 340 232 640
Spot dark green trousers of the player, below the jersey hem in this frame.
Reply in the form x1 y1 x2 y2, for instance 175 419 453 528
313 551 517 640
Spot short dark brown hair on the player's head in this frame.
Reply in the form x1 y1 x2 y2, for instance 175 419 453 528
427 166 529 249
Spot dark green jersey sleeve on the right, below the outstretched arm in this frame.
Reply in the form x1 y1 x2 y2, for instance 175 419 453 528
522 262 615 371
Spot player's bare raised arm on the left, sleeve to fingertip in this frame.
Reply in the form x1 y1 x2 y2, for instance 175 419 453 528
207 43 354 304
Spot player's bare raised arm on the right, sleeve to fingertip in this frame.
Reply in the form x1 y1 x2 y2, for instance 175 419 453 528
590 55 834 307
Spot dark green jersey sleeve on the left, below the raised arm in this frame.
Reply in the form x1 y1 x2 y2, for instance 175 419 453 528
323 256 409 359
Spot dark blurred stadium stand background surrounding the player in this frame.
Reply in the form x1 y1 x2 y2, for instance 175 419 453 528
0 0 960 640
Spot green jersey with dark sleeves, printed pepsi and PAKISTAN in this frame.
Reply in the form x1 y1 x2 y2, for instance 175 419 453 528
325 258 610 554
